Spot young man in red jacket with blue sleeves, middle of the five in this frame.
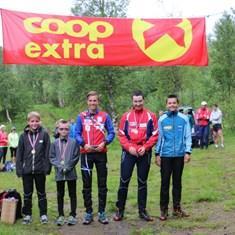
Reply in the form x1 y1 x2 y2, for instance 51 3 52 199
76 91 115 225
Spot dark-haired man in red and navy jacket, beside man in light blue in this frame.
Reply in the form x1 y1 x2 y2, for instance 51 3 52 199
113 91 158 221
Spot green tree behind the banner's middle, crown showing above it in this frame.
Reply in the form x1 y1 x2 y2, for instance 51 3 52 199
68 0 128 125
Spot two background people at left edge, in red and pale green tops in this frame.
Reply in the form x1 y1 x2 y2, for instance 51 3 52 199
0 125 19 165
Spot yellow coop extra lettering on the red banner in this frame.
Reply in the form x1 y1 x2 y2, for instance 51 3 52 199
23 17 114 59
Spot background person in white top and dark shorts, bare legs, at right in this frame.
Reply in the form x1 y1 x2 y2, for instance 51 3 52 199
210 104 224 148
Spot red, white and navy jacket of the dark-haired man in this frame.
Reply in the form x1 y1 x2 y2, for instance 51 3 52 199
118 109 158 151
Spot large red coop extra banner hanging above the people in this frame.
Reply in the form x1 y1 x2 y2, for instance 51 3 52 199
1 10 208 66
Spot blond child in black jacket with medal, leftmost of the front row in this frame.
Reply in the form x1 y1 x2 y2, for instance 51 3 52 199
16 112 51 224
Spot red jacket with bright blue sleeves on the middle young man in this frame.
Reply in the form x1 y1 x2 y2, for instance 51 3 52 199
76 110 115 153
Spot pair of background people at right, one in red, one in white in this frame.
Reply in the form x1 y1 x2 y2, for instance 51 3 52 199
195 101 224 149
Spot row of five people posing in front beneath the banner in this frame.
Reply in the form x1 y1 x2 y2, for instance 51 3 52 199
11 91 192 225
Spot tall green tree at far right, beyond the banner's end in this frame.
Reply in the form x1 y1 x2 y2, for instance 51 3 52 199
210 10 235 128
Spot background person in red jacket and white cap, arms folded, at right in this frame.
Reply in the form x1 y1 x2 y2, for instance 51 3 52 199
196 101 211 149
